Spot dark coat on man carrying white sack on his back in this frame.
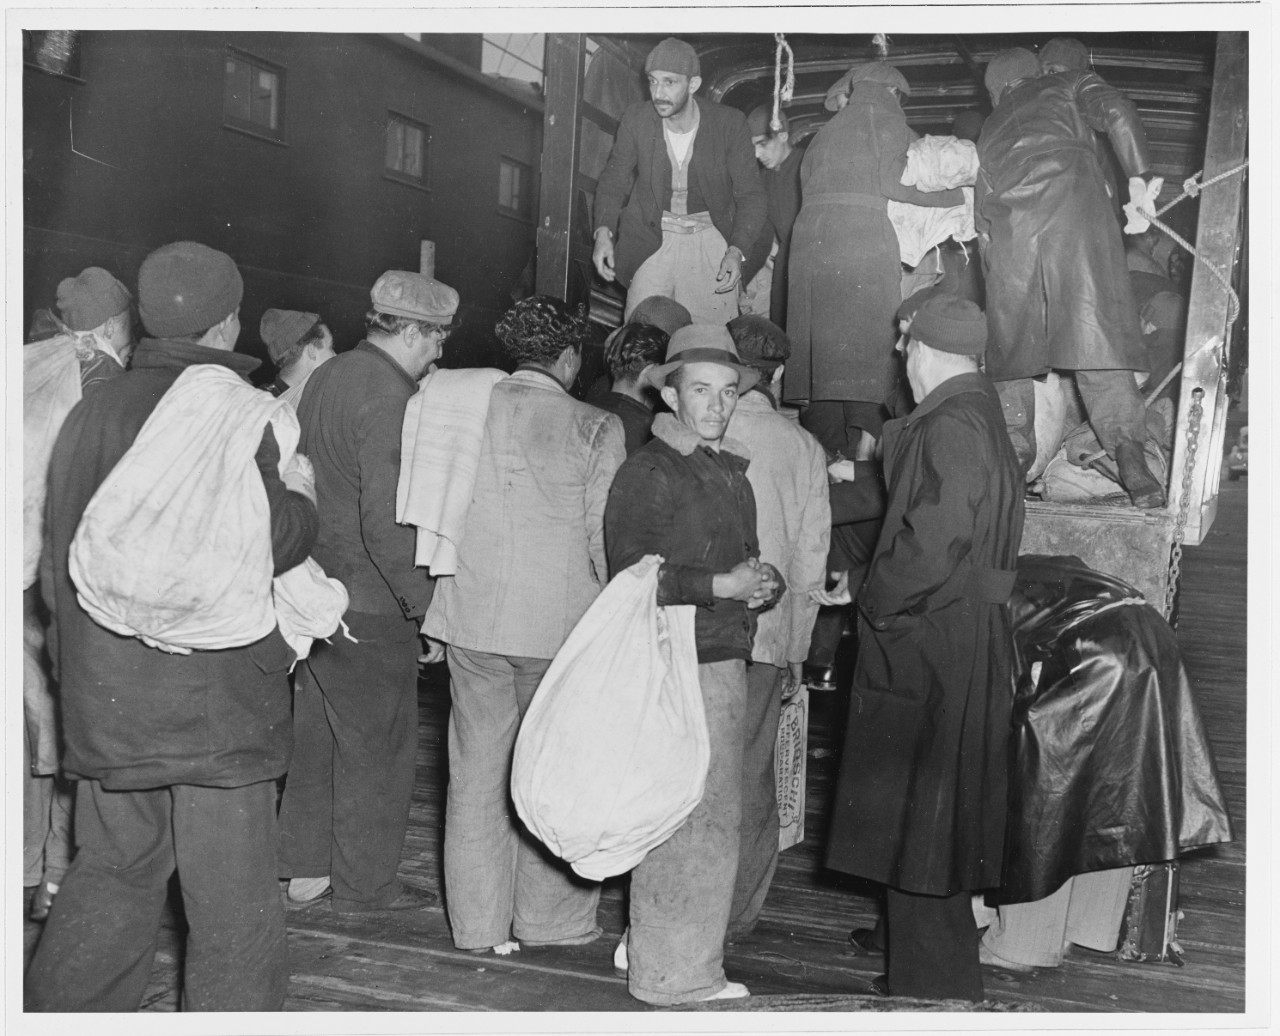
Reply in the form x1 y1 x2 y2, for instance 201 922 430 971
41 339 319 791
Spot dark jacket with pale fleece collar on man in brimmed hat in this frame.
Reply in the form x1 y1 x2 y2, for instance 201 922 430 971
604 414 760 663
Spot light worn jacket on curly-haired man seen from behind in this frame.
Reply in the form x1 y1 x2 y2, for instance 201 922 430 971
422 370 626 658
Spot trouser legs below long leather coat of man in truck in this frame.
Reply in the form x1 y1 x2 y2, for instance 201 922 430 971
996 370 1147 469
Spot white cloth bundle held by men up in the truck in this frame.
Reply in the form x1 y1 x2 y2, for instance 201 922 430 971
888 134 978 266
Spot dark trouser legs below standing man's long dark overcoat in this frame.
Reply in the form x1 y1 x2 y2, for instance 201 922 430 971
884 889 983 1003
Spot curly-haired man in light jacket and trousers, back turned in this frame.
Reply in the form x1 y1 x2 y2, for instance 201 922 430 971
422 295 626 953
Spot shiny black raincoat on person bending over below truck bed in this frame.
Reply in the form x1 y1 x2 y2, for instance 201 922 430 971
1000 556 1231 903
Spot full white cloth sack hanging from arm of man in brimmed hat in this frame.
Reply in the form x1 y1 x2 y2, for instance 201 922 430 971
511 556 710 881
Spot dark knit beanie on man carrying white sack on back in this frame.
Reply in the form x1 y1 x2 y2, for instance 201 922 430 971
138 241 244 338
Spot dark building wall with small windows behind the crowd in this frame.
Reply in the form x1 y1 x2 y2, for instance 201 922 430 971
23 32 541 362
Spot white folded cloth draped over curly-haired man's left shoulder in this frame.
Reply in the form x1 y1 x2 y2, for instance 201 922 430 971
396 368 507 576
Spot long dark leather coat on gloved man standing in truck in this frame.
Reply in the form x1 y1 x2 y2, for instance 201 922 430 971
974 70 1151 382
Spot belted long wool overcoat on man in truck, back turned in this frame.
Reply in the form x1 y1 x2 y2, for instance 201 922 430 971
782 82 964 403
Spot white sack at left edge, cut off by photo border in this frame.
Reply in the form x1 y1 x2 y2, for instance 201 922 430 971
22 334 81 590
